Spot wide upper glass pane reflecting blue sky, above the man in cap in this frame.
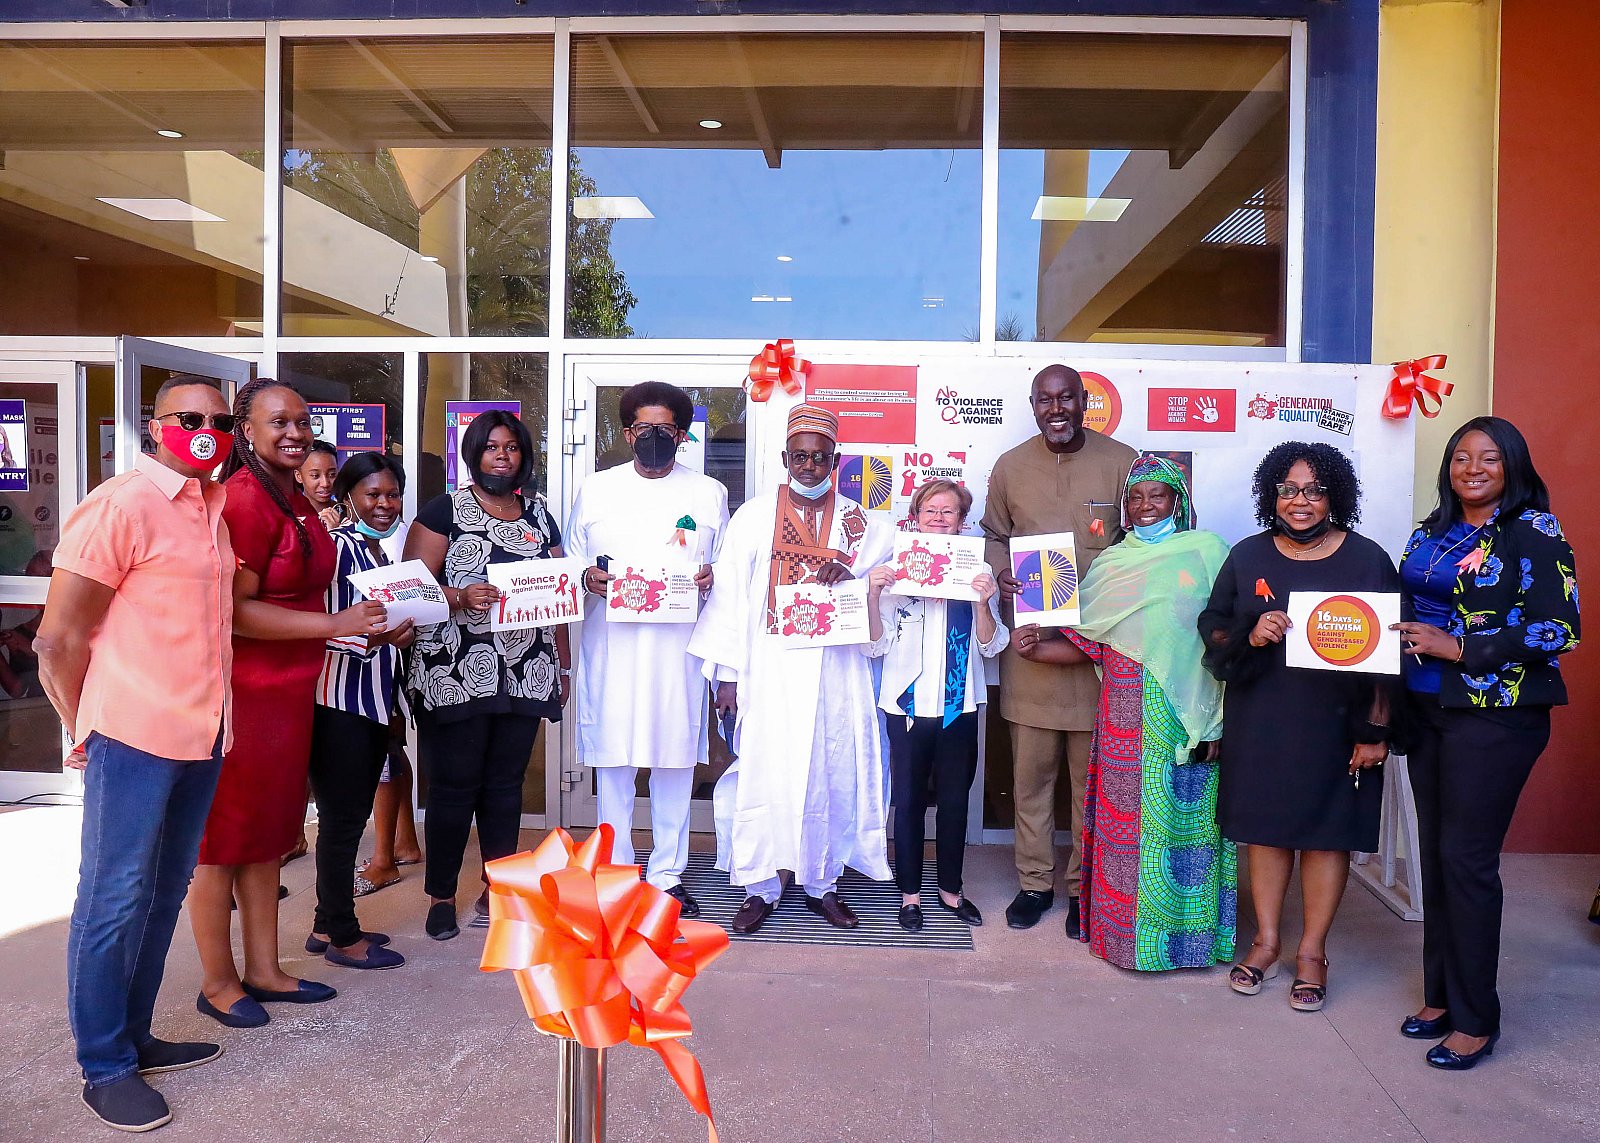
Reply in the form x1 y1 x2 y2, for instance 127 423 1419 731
566 35 982 341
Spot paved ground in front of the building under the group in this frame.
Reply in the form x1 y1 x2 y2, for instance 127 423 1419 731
0 810 1600 1143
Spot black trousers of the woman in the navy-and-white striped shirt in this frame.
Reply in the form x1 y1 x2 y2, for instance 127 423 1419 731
310 706 389 948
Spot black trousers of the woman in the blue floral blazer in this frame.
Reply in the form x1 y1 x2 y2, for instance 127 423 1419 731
1406 695 1550 1036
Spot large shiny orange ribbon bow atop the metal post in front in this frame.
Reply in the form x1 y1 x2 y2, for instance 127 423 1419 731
478 824 728 1143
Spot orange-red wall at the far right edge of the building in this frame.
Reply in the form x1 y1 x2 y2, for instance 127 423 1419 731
1494 0 1600 853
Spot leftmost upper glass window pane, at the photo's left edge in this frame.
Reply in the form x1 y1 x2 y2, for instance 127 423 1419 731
0 42 264 336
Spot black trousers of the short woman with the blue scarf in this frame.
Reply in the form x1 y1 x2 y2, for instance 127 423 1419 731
883 714 978 895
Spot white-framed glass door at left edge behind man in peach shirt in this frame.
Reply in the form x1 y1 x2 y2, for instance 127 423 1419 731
0 360 85 800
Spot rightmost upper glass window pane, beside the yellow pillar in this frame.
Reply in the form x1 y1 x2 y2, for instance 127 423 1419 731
997 34 1290 346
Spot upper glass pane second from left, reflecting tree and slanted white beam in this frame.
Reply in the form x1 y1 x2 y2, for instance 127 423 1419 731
283 37 555 336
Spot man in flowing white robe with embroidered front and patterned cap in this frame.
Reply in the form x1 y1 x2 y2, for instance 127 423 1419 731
690 405 894 933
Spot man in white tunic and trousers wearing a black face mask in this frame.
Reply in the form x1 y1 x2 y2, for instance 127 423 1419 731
565 381 728 917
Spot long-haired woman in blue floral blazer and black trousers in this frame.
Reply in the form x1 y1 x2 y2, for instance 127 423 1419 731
1397 416 1578 1071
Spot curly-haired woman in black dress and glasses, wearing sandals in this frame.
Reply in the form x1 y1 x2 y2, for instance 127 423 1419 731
1198 440 1398 1012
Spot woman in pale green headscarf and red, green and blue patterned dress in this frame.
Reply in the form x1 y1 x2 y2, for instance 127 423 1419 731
1016 456 1238 970
